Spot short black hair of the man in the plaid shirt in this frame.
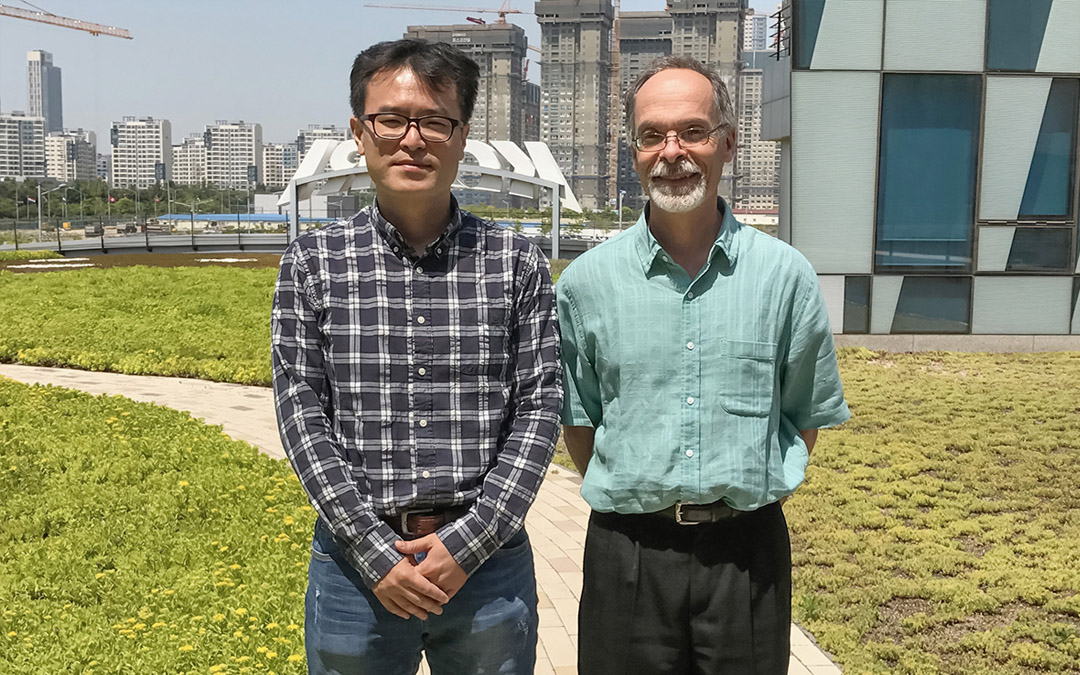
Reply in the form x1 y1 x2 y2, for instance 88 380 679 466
349 38 480 122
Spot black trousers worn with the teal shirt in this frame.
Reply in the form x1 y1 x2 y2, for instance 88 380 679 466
578 504 792 675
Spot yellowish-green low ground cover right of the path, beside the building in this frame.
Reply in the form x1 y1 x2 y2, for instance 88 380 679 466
785 350 1080 675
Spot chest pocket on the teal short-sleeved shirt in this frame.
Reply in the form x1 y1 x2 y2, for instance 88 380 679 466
718 340 777 417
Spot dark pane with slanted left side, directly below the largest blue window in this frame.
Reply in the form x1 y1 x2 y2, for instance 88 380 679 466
891 276 971 333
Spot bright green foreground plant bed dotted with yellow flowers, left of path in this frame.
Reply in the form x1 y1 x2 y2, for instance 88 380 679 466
0 378 314 674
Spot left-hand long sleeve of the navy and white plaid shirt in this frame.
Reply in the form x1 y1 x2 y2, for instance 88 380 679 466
271 240 402 586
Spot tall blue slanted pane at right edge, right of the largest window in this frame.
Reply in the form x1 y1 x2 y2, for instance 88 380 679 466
1020 78 1080 218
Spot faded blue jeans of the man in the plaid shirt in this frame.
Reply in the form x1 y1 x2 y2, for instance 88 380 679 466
305 518 539 675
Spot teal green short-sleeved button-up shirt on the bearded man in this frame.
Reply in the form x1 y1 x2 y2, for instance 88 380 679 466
556 200 850 513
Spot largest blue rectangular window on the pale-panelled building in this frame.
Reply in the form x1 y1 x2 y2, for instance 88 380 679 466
876 73 983 270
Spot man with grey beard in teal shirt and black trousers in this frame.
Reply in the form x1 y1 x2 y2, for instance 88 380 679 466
556 56 849 675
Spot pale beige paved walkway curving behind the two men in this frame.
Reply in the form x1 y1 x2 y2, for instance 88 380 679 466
0 364 840 675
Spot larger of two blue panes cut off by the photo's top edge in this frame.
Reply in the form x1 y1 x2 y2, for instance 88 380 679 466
986 0 1061 72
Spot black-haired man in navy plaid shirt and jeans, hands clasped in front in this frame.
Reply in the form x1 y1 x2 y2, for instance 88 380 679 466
272 40 562 675
